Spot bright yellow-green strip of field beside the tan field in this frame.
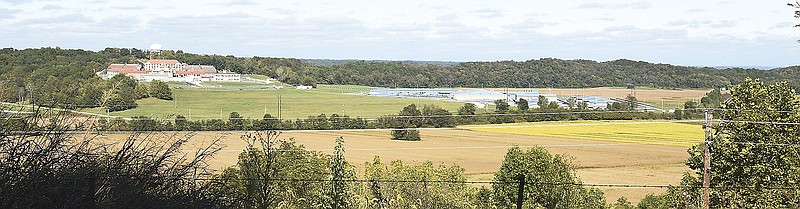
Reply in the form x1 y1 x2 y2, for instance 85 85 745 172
459 121 704 147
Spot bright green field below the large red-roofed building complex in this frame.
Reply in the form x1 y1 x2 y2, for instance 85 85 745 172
84 82 462 119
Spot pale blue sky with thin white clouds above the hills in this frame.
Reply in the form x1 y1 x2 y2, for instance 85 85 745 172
0 0 800 67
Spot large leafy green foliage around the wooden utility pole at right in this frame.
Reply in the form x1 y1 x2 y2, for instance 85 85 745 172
640 79 800 208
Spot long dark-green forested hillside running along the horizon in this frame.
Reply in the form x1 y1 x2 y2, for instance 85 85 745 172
0 48 800 101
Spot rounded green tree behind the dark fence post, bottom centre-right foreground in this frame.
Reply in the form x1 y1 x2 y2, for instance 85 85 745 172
492 147 606 208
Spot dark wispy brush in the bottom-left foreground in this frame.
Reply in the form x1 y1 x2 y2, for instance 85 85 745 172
0 107 225 208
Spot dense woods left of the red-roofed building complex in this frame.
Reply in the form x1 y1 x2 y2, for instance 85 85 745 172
0 48 172 111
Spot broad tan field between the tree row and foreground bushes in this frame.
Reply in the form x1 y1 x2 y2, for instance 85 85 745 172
97 121 702 203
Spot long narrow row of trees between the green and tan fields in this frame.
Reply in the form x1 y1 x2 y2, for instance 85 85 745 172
84 104 701 132
